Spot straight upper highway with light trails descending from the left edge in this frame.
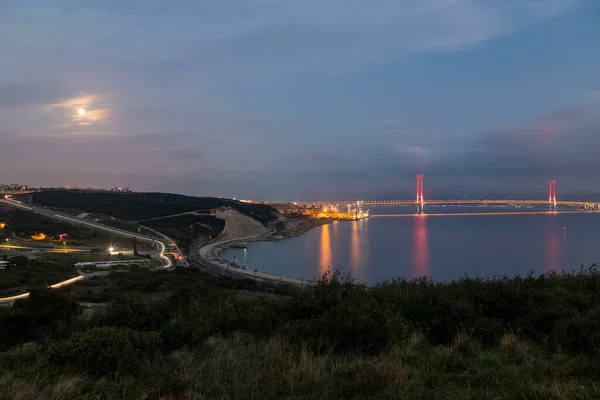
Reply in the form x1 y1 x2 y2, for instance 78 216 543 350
0 195 173 268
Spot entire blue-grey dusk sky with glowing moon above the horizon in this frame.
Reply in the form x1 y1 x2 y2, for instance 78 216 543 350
0 0 600 200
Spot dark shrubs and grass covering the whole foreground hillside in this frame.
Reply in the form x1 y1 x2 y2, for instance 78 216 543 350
0 266 600 399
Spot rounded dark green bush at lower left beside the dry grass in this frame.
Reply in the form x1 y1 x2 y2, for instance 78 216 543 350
49 327 161 375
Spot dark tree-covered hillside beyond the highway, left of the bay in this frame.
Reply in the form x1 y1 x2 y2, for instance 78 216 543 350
31 190 278 224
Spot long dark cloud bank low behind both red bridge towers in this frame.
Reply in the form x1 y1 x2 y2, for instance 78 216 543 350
294 108 600 198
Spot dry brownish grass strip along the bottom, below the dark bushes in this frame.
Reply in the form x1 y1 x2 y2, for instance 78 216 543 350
0 334 600 399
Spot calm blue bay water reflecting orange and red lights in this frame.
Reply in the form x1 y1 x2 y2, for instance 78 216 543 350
222 208 600 284
